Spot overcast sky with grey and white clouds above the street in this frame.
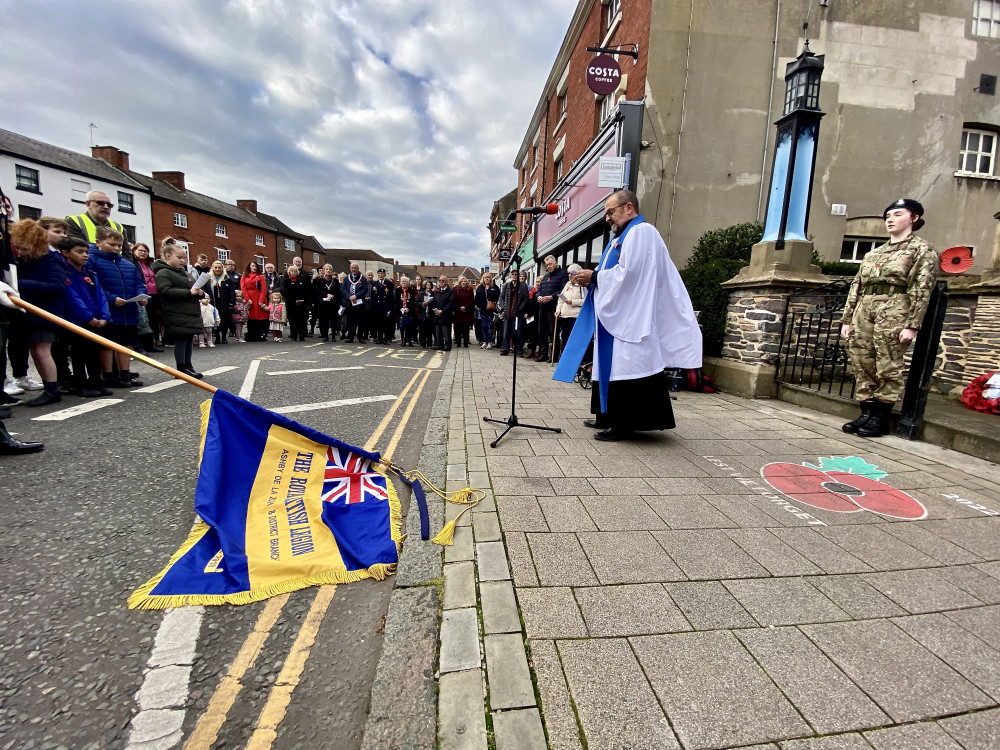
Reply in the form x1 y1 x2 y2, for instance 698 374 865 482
0 0 576 266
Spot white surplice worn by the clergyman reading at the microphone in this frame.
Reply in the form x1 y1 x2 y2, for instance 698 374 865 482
594 222 701 380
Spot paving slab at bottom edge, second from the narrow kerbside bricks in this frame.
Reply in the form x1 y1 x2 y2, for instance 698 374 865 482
558 638 680 750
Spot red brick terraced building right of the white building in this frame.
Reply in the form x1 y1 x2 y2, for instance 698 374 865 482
93 146 277 273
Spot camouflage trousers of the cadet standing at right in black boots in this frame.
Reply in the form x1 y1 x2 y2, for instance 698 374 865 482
847 294 910 403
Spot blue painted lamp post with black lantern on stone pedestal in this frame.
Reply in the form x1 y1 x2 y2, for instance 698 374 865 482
762 40 824 250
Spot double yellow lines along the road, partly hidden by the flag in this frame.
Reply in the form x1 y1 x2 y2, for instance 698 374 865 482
184 370 431 750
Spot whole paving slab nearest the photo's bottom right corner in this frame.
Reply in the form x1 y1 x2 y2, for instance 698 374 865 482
801 620 992 723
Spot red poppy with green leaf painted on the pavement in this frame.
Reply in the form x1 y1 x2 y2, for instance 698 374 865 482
760 456 927 521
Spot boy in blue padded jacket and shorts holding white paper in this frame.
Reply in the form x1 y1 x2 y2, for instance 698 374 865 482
87 226 149 388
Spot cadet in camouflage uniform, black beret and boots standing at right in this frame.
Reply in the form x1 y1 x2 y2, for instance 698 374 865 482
841 198 938 437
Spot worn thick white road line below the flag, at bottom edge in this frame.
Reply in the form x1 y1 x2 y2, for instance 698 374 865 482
125 607 205 750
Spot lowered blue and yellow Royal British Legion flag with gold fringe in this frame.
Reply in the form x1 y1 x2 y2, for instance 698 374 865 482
129 390 402 609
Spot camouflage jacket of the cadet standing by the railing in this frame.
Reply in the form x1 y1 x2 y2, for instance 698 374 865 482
841 234 938 328
